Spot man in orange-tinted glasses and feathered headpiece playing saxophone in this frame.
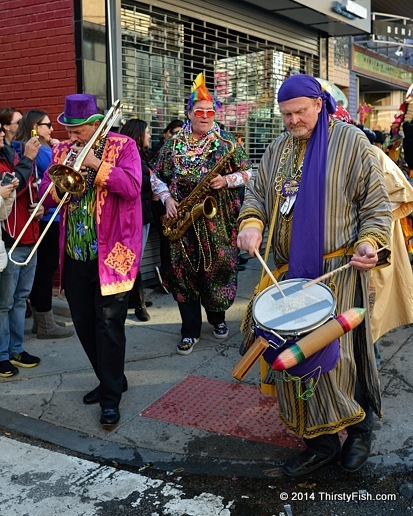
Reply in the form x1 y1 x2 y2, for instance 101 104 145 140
151 74 251 355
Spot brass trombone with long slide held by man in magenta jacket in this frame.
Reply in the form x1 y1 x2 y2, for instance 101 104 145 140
8 100 122 266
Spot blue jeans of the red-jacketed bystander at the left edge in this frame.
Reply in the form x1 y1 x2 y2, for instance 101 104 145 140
0 245 37 361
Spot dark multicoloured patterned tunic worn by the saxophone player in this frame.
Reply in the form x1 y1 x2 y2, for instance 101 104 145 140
153 126 251 312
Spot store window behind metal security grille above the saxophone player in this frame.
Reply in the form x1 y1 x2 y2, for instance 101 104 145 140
121 0 319 164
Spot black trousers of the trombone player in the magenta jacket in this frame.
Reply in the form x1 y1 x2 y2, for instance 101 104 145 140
63 255 129 408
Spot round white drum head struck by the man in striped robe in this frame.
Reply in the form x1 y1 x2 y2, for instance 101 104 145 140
252 278 336 336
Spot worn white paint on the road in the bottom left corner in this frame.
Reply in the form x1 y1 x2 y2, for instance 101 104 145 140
0 436 232 516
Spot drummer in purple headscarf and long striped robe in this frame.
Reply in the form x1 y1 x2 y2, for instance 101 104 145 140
238 75 391 477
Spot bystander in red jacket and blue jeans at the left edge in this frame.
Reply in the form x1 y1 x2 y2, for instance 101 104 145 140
0 114 43 378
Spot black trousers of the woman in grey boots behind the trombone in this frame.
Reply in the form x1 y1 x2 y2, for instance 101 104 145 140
29 220 59 312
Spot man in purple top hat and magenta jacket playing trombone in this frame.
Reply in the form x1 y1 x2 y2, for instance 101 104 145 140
40 94 142 429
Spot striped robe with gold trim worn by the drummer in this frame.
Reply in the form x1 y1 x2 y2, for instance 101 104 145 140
239 121 392 438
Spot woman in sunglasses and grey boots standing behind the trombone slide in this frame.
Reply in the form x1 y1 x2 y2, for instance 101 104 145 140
13 109 74 339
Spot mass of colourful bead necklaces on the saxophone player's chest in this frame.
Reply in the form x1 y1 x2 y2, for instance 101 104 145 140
174 123 219 176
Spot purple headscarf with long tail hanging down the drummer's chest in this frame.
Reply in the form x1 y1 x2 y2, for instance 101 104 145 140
278 74 336 279
